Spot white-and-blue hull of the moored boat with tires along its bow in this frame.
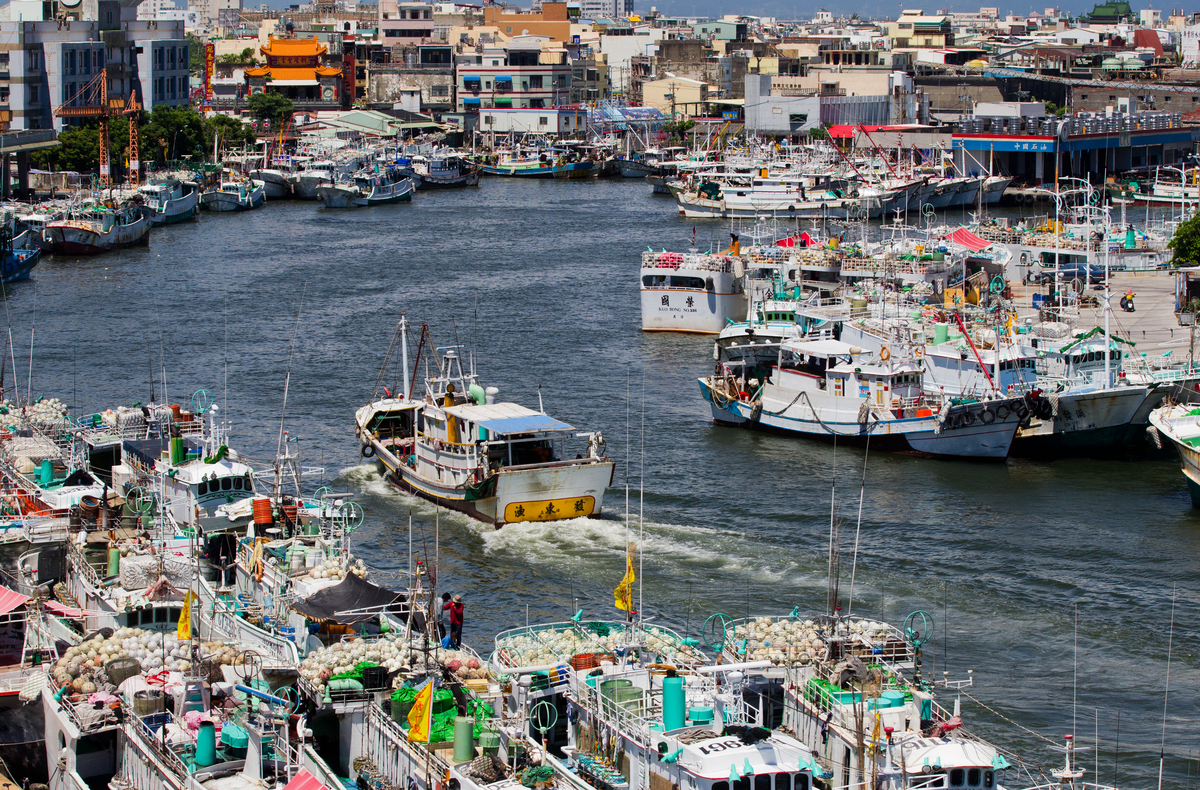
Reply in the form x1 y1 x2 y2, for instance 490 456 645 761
700 379 1018 461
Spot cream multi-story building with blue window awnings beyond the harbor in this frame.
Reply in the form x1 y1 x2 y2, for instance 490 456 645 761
455 41 571 113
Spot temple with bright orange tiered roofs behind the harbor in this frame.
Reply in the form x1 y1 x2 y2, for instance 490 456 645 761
246 36 353 109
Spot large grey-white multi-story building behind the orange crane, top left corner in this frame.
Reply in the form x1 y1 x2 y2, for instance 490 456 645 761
0 11 190 131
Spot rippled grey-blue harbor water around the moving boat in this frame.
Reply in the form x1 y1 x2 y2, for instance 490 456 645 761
7 180 1200 788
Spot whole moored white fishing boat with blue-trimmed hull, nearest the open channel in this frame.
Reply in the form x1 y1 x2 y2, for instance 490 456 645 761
700 337 1024 460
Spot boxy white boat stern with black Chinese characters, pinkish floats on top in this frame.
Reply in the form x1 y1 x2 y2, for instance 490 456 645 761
641 243 746 335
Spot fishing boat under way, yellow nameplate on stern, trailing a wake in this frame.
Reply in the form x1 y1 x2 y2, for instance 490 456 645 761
354 318 614 527
